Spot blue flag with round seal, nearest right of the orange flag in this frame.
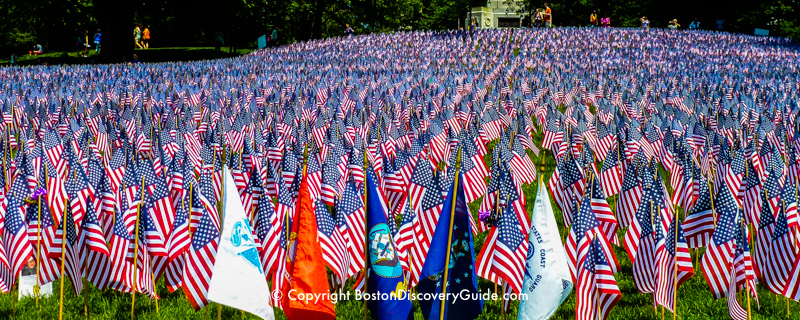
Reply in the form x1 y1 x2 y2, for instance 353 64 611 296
366 170 411 320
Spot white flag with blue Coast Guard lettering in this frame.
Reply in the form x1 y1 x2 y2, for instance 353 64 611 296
518 180 573 320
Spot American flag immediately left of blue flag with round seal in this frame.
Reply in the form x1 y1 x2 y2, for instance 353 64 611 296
336 180 366 278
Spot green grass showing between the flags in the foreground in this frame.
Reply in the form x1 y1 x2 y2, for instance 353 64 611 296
0 123 800 320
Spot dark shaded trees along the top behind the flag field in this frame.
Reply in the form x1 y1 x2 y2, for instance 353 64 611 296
0 0 800 61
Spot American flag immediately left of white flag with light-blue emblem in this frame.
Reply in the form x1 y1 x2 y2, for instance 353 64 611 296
182 195 220 310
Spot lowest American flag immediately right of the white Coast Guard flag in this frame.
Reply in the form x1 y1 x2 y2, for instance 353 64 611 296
575 235 622 320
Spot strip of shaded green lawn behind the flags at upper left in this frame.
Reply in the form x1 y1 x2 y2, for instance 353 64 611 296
0 47 254 65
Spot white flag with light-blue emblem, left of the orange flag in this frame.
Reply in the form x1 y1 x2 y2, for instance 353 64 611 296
208 169 275 320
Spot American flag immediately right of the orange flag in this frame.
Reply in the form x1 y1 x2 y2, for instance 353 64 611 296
314 201 350 283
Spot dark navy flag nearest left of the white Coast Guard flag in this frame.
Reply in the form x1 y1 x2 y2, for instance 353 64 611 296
417 169 483 320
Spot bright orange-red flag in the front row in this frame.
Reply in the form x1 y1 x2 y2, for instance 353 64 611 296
282 176 336 320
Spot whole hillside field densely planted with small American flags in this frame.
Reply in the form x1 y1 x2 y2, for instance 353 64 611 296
0 28 800 320
